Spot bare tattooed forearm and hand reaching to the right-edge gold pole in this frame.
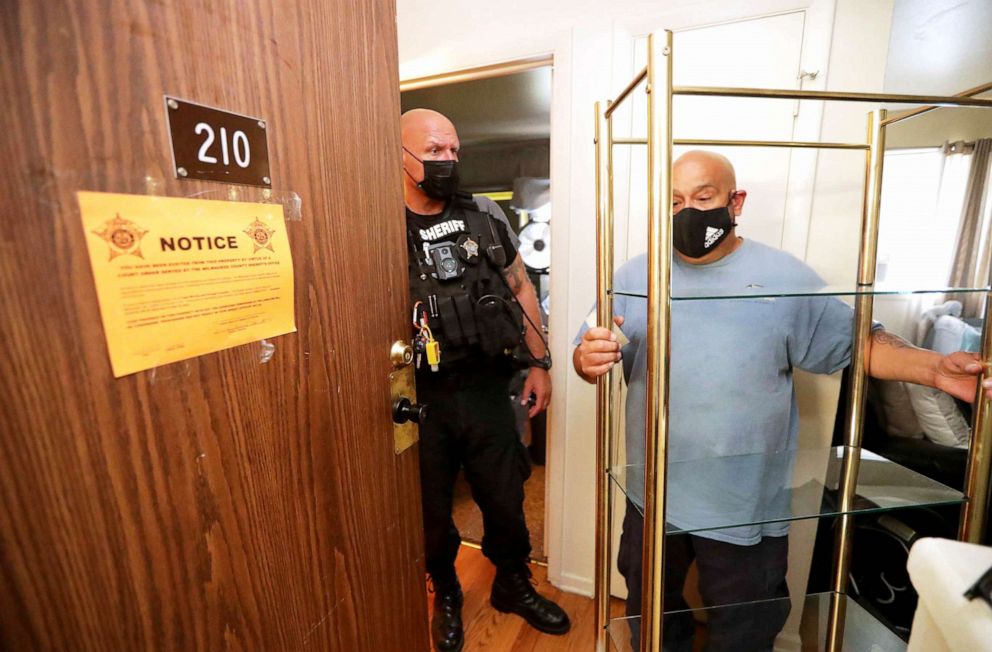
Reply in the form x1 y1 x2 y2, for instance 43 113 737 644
865 329 992 403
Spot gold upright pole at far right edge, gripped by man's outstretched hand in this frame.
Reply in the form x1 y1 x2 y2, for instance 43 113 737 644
958 294 992 543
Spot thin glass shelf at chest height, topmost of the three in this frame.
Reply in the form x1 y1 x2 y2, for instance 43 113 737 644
609 284 990 301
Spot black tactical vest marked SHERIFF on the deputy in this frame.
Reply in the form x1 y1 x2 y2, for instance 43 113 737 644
407 197 526 371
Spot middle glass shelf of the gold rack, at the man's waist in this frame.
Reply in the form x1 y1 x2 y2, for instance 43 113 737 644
609 446 964 533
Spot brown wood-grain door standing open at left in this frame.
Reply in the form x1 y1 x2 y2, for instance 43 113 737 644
0 0 428 652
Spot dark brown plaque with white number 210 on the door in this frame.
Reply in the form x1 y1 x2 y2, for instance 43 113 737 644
165 95 272 188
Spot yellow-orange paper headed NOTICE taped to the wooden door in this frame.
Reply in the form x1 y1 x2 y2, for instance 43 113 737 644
77 192 296 377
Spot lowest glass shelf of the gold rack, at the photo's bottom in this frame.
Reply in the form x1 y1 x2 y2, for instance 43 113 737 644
607 593 906 652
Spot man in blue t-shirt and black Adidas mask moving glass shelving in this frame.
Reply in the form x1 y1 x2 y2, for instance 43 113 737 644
573 151 992 652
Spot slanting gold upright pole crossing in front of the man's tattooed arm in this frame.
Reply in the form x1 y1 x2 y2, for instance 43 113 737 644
827 109 887 652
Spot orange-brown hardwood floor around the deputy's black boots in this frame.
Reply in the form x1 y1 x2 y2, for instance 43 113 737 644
428 546 595 652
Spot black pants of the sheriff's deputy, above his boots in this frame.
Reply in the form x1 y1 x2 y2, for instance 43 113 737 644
417 374 530 582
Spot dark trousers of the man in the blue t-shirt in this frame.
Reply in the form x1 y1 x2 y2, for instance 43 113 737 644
617 501 789 652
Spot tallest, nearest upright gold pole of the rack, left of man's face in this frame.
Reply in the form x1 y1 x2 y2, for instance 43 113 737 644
641 30 672 652
